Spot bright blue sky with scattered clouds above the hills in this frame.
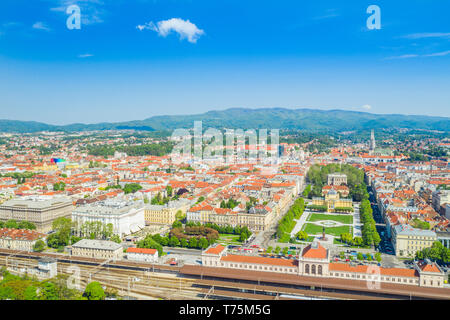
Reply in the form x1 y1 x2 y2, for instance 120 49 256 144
0 0 450 124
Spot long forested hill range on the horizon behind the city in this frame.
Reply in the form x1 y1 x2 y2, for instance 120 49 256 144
0 108 450 132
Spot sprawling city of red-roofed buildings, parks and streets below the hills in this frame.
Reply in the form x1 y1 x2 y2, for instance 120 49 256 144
0 129 450 299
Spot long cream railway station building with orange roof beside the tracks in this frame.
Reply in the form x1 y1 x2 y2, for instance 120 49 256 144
202 242 445 288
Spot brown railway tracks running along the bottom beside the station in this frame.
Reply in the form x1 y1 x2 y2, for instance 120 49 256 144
0 249 426 300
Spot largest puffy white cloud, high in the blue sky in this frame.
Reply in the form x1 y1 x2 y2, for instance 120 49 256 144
136 18 205 43
